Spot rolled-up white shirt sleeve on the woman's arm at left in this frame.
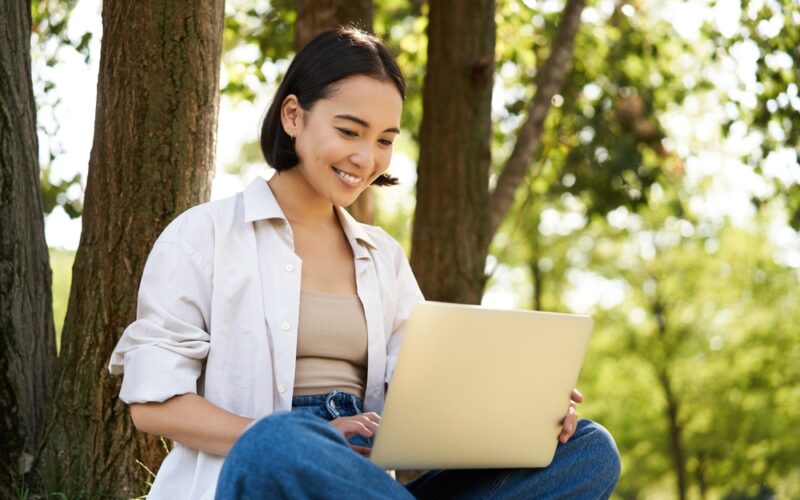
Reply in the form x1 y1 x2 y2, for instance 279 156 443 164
108 235 212 404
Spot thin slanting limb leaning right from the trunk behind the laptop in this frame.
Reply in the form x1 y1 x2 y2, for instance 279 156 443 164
489 0 585 239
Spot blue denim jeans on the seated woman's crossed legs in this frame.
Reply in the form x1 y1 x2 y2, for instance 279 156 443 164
216 392 620 500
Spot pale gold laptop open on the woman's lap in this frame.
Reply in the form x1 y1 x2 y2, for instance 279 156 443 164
371 302 593 469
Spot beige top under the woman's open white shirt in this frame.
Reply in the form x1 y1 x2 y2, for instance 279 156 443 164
294 292 367 399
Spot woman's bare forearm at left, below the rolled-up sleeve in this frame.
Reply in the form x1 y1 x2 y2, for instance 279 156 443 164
131 394 253 457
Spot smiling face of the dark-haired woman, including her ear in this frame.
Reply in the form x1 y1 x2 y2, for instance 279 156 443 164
282 75 403 207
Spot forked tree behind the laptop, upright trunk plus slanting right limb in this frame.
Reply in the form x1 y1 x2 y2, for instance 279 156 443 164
411 0 584 303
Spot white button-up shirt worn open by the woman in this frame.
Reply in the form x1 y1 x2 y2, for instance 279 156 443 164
109 178 432 500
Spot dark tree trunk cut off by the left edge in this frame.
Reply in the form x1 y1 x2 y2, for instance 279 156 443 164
0 0 56 498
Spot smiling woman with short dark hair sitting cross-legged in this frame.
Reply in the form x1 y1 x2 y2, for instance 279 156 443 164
110 28 618 499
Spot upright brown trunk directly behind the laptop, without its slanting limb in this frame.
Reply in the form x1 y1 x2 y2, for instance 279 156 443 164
411 0 495 304
